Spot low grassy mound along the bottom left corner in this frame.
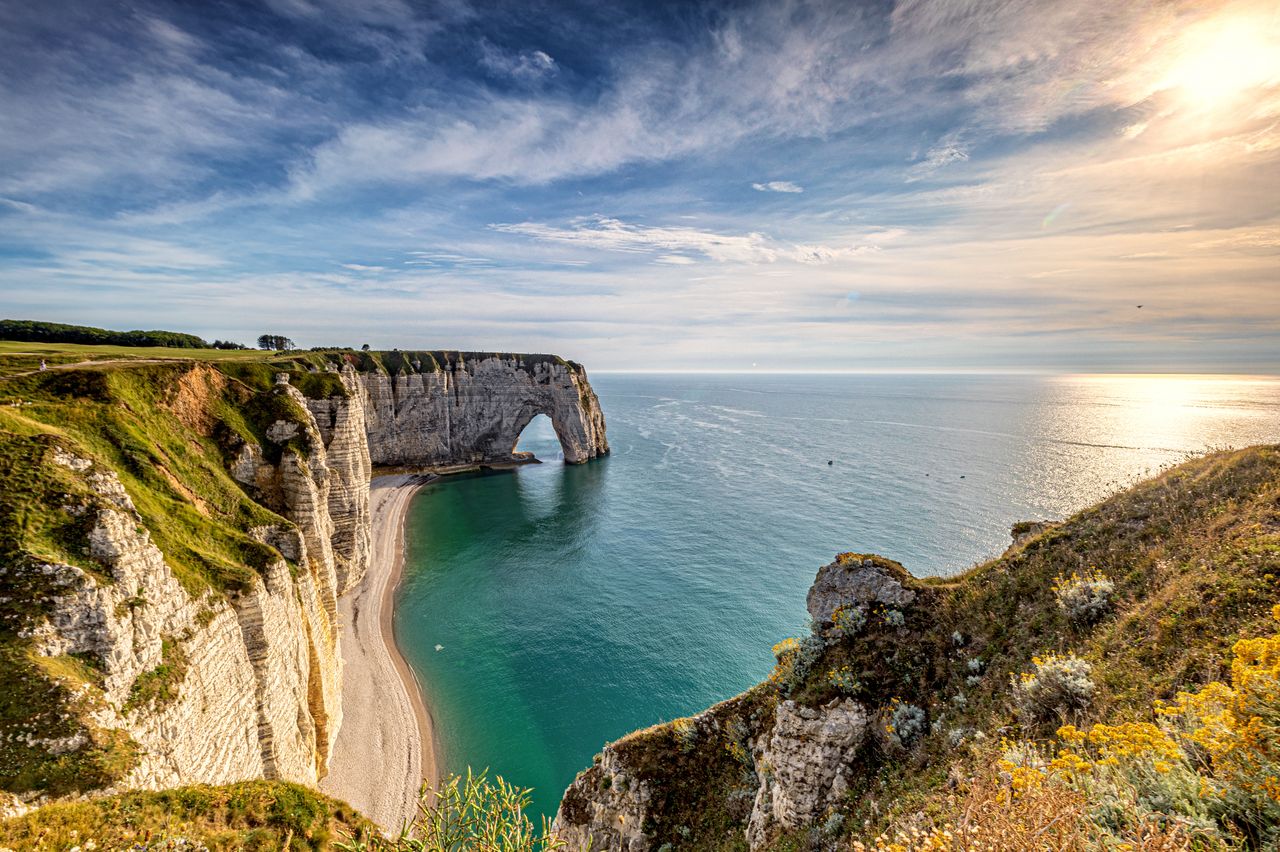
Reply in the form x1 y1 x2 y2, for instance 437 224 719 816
0 782 371 852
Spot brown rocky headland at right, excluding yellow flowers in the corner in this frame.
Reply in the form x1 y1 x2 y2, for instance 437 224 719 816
554 446 1280 852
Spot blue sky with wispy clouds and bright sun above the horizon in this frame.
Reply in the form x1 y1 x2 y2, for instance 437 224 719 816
0 0 1280 372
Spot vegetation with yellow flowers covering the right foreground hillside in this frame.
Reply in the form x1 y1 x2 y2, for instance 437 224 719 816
561 446 1280 851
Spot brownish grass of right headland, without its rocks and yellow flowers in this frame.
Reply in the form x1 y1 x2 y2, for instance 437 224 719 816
566 446 1280 849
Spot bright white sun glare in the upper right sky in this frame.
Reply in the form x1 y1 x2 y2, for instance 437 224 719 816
1161 14 1280 109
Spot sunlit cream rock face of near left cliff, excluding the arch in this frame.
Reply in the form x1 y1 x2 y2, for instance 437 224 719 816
24 372 370 788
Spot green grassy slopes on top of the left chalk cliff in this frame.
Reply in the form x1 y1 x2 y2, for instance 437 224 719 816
0 347 355 794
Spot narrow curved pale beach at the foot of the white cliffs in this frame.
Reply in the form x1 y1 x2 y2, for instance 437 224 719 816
320 475 438 833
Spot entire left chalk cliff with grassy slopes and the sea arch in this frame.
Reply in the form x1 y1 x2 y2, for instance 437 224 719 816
0 353 608 801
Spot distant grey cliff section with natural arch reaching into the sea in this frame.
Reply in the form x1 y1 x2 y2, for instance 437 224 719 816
360 352 609 467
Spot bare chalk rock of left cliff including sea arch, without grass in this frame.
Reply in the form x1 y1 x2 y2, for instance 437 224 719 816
0 353 608 801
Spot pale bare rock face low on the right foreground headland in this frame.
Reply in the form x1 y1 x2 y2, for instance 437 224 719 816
746 698 868 849
